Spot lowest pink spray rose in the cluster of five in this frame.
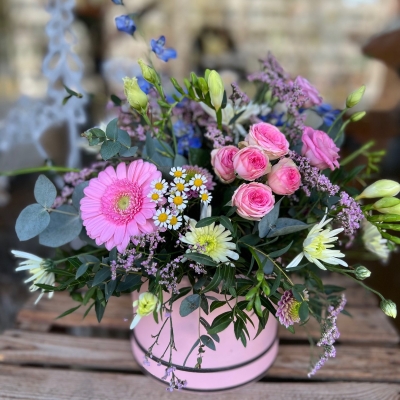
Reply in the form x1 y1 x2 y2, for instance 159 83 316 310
232 182 275 221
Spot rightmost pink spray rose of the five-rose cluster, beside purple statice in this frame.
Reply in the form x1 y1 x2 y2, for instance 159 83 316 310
268 158 301 195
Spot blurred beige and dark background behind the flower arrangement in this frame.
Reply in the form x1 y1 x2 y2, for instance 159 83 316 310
0 0 400 331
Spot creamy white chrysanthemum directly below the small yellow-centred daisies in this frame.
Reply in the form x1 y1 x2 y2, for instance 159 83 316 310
181 219 239 263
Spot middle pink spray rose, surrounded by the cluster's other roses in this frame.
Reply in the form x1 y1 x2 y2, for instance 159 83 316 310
233 146 271 181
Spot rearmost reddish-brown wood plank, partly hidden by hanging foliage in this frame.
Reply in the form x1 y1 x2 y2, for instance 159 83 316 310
17 293 399 345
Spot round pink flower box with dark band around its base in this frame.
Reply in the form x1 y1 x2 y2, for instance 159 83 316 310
131 286 279 392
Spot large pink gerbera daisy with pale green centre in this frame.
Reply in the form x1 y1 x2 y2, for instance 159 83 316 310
81 160 161 253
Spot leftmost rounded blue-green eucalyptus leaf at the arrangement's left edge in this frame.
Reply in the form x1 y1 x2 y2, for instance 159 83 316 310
15 204 50 241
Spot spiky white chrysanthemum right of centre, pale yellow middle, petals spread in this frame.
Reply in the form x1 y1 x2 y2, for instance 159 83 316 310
286 215 347 269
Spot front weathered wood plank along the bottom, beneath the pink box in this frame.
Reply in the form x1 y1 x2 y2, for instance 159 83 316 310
0 366 400 400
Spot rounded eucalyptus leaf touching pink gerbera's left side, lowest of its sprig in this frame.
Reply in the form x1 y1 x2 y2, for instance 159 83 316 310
39 204 82 247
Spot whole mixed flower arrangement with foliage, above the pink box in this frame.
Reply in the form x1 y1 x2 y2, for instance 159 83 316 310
9 7 400 390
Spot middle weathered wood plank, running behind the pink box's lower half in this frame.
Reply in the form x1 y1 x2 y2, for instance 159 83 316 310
0 330 400 383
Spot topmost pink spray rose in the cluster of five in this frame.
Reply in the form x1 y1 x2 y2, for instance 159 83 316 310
245 122 289 160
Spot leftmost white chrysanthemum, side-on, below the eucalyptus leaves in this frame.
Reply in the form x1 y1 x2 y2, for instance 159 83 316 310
11 250 55 304
